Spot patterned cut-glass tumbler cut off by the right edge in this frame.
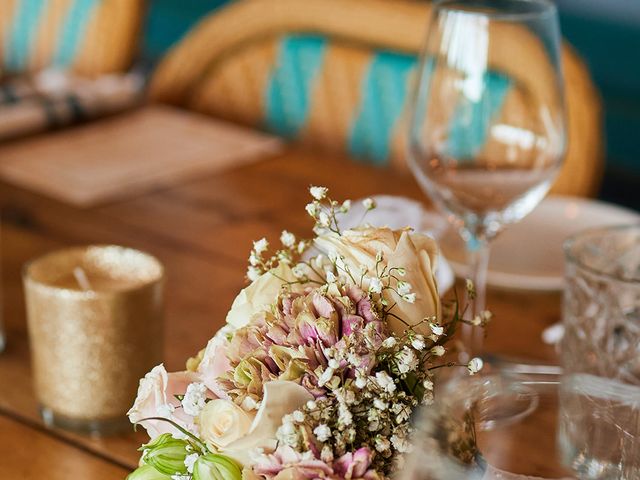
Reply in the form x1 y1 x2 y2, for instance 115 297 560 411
559 224 640 480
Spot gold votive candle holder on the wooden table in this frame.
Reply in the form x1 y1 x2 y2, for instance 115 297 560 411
23 245 164 434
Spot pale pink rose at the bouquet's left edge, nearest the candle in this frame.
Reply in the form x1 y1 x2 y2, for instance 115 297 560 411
127 364 198 439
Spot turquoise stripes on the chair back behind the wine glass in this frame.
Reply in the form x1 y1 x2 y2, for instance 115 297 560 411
263 35 510 165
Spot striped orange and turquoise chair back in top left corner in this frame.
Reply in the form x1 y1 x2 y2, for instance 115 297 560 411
0 0 143 75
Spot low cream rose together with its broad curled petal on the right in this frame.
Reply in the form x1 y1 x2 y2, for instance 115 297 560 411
200 380 313 465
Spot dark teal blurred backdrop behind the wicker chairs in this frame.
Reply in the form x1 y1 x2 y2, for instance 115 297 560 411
142 0 640 209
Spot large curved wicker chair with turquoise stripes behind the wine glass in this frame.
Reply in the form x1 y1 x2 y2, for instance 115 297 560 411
151 0 603 195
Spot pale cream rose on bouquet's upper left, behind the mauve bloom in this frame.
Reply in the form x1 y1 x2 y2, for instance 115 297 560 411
227 263 296 328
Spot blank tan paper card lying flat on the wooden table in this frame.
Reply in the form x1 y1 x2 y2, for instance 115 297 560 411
0 106 282 207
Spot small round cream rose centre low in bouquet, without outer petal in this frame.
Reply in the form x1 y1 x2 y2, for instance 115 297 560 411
200 399 253 449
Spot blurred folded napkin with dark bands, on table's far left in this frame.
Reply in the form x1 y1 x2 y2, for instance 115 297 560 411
0 70 144 141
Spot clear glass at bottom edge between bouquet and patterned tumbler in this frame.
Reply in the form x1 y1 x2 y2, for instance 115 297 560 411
398 372 571 480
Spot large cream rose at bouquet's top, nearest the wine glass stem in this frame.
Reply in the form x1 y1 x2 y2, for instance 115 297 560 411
315 227 440 334
